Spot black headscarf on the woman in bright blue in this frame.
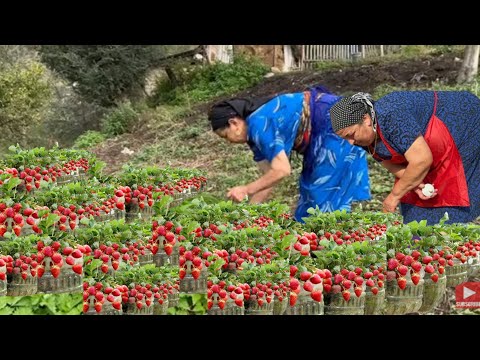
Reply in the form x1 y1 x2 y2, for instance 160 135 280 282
208 95 275 131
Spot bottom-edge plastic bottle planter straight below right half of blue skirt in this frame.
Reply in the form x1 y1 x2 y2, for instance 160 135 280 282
325 283 366 315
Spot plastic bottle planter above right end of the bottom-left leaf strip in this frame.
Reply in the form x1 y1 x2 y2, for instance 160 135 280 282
37 257 83 294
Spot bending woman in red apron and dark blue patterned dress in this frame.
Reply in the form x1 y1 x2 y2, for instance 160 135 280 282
330 91 480 224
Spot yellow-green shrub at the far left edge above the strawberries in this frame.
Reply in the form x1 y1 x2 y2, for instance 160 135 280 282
0 63 52 148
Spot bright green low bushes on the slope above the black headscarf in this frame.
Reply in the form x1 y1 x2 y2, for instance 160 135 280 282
150 55 268 106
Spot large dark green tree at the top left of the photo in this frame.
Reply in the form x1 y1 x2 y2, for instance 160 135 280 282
39 45 164 107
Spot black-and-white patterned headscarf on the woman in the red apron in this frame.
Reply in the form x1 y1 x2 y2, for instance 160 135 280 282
330 93 377 132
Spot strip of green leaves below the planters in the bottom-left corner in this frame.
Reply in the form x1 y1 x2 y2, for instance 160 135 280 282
0 293 83 315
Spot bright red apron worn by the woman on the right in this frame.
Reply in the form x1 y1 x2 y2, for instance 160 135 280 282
374 92 470 208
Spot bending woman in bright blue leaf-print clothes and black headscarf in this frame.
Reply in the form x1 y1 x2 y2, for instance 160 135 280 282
209 86 371 221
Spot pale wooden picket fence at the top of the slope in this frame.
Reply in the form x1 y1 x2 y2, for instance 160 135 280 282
300 45 400 69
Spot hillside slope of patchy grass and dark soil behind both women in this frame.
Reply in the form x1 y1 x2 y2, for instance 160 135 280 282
92 54 461 210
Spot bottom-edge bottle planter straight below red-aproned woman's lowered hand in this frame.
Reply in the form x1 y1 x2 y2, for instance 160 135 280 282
385 269 424 315
